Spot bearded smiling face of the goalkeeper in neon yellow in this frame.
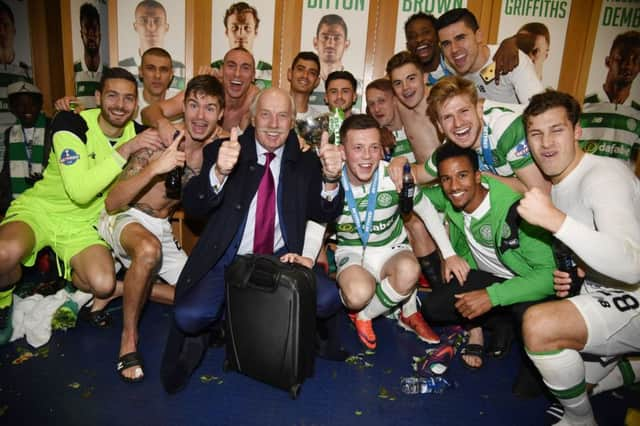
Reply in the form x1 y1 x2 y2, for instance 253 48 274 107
96 78 138 130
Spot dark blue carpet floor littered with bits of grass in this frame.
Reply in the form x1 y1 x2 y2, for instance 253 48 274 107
0 296 640 426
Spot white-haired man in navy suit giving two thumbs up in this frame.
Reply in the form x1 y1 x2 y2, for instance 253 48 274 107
161 88 343 393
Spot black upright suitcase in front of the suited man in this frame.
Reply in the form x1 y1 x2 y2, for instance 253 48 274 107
224 255 316 399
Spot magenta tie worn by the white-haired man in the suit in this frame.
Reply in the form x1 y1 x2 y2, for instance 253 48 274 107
253 152 276 254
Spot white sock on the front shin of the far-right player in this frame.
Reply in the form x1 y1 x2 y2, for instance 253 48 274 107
527 349 596 425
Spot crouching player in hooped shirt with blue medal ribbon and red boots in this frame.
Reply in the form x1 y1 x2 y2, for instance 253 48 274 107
288 114 469 350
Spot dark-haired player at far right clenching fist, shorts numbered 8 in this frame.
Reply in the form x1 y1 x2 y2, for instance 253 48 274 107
518 91 640 426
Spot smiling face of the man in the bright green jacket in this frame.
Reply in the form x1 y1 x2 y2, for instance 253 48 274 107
438 156 487 213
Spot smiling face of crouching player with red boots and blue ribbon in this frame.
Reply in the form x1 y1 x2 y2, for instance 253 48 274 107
340 128 383 185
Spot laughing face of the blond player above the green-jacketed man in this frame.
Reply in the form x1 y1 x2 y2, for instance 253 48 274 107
437 94 483 148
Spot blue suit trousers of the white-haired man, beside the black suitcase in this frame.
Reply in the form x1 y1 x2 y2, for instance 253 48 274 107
174 250 342 334
